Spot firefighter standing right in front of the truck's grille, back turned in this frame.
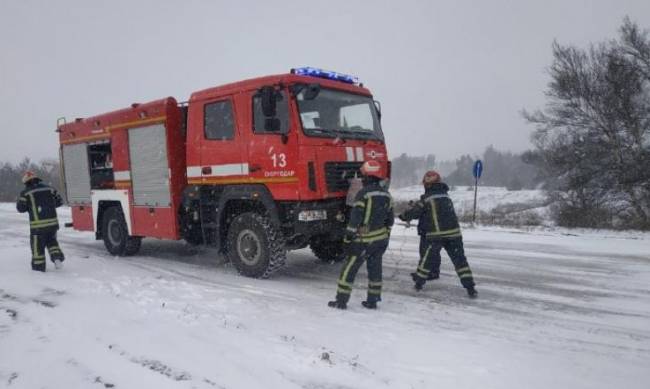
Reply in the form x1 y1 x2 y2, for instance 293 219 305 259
328 160 394 309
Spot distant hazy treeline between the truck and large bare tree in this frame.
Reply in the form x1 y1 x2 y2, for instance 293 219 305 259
391 146 543 190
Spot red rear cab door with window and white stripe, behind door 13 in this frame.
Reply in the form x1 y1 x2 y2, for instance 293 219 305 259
188 97 249 184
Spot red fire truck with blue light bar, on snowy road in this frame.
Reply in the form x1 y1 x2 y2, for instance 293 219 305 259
57 67 390 278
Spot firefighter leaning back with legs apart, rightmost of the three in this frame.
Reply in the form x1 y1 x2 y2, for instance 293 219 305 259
398 170 478 298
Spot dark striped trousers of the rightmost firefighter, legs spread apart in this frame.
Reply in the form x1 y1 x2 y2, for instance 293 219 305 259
415 237 474 288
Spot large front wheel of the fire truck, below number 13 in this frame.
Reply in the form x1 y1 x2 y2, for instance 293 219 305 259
226 212 287 278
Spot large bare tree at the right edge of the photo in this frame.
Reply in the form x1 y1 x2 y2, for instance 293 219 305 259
524 18 650 228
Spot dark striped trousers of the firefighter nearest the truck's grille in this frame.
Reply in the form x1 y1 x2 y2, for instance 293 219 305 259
336 239 388 303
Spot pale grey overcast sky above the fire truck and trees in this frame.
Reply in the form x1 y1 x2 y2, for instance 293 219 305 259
0 0 650 162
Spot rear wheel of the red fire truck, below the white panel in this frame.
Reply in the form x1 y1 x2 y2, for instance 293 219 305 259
102 207 142 256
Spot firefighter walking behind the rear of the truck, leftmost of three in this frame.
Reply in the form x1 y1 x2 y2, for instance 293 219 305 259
16 171 65 272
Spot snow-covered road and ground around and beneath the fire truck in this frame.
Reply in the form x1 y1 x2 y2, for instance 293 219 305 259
0 204 650 389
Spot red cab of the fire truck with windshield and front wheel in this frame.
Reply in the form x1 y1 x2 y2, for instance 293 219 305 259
183 68 389 276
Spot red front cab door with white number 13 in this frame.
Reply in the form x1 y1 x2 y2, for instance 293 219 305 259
247 89 299 200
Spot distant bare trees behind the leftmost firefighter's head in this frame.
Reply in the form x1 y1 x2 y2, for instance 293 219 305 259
0 158 63 202
